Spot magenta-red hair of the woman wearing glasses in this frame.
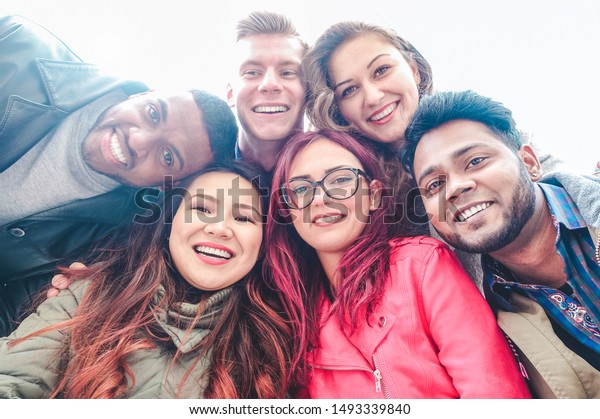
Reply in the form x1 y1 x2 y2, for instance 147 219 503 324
265 130 410 383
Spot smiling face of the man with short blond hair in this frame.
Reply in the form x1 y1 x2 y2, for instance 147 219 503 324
233 34 306 141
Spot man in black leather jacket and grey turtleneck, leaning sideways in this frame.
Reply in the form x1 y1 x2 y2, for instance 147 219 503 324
0 16 237 335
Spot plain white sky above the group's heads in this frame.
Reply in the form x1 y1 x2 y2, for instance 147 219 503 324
0 0 600 173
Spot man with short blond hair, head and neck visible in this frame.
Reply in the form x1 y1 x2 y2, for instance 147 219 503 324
227 12 308 171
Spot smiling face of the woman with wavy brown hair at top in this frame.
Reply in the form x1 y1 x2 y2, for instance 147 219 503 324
329 33 420 143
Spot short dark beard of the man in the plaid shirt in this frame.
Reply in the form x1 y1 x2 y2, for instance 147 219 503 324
440 165 536 254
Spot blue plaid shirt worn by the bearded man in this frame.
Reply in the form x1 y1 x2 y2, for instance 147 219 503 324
483 182 600 356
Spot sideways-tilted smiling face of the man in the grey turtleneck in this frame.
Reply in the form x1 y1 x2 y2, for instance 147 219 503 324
83 91 213 186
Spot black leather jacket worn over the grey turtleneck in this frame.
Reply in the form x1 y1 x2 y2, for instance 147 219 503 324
0 16 148 336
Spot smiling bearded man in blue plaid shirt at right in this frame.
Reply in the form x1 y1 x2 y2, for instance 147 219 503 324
402 91 600 398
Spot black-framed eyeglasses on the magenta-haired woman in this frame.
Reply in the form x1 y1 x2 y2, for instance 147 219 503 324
280 167 371 210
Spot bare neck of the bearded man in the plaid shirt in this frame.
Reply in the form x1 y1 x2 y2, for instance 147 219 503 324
490 188 566 288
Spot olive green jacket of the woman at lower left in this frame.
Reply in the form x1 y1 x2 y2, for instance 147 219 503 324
0 281 231 399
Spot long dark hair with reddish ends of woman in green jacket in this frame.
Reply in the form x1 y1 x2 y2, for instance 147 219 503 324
13 162 292 398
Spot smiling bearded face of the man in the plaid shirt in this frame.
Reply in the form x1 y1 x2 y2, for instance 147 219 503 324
414 120 537 253
